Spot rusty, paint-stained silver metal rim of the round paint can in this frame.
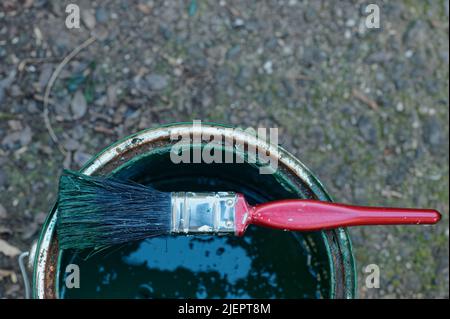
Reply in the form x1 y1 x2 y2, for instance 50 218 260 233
32 122 357 299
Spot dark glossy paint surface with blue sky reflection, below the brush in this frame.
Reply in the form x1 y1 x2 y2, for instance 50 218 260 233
60 227 320 298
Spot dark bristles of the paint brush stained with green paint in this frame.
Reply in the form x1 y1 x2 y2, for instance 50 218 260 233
57 170 171 249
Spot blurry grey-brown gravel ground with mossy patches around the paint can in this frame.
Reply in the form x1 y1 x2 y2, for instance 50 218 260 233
0 0 449 298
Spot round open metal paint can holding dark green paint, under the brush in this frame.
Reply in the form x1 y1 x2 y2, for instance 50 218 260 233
26 123 356 299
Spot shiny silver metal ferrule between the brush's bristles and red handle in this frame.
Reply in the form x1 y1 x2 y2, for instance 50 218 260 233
171 192 237 235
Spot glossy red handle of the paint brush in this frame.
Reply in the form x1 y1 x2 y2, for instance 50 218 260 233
237 197 441 234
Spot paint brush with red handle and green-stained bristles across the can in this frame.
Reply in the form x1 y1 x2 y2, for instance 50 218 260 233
57 170 441 249
